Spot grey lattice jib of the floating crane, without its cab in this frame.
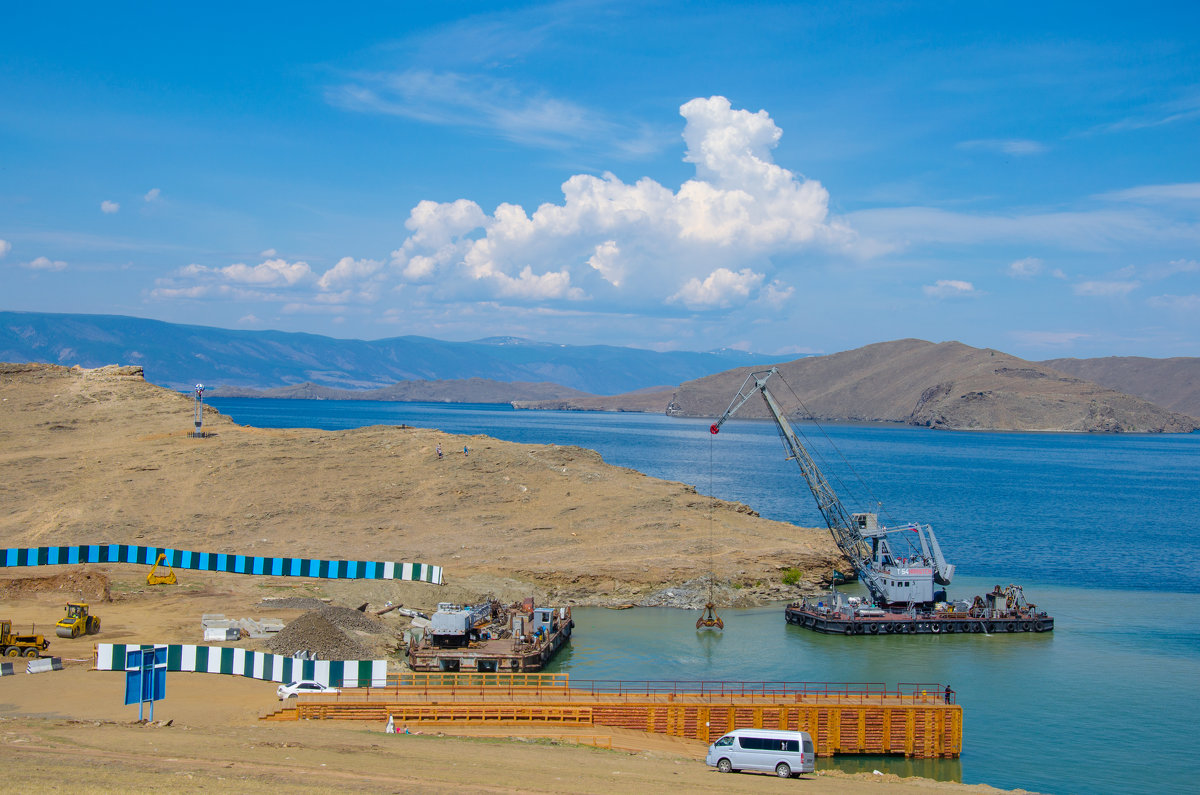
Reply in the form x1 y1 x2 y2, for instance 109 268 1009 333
710 367 872 586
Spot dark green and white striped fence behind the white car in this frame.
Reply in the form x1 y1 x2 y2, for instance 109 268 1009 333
95 644 388 687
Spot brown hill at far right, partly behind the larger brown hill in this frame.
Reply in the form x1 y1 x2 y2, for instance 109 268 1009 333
1042 357 1200 417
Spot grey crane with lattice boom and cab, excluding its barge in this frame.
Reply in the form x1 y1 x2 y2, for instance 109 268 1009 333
709 367 954 605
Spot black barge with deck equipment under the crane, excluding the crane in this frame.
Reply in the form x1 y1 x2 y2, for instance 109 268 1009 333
784 585 1054 635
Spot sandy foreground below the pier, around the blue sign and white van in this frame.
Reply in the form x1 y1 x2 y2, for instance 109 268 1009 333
0 664 1022 794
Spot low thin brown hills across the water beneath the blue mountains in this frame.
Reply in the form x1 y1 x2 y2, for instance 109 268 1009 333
218 378 590 404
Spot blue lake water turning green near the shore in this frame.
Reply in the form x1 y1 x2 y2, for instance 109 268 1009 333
211 399 1200 793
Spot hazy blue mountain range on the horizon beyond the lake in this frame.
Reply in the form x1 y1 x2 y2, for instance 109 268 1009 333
0 312 778 400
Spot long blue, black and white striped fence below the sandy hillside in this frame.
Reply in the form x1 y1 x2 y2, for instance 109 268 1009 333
0 544 442 585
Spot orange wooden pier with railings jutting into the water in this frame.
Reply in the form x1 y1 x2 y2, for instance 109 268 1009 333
263 673 962 759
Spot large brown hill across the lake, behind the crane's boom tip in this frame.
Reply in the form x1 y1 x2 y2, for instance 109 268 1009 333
668 340 1198 432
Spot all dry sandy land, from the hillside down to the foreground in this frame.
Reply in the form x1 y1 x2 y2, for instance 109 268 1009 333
0 365 1036 793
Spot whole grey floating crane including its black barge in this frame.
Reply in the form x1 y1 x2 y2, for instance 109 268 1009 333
709 367 1054 635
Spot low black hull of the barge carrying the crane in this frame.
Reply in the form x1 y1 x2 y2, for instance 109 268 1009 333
784 604 1054 635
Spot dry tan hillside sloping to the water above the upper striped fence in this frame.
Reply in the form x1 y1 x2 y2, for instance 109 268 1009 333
0 365 838 608
